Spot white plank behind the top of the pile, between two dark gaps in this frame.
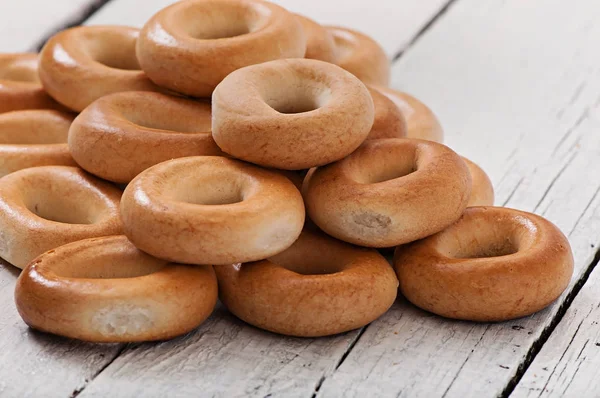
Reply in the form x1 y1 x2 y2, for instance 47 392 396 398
87 0 448 57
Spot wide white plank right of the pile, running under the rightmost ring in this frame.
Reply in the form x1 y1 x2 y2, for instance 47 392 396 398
319 0 600 397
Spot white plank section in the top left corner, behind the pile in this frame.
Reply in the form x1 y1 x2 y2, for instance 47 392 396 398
0 0 101 53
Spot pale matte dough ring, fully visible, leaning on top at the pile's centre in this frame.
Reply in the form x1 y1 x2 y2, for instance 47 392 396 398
212 59 374 170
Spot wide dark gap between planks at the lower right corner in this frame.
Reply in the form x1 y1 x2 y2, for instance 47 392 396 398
500 244 600 398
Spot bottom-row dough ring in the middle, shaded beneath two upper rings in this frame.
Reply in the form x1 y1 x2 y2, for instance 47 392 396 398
215 230 398 337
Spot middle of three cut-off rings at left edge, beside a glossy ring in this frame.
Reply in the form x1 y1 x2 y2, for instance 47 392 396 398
0 110 76 177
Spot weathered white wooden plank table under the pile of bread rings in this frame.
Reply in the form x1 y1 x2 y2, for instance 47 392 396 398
0 0 600 397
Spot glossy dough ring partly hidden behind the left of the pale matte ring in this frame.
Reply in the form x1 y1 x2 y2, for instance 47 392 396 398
69 91 223 183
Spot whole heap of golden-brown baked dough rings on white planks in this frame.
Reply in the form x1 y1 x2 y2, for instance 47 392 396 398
0 0 573 342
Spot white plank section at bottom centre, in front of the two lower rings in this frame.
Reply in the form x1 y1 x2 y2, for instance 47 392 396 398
80 305 357 398
